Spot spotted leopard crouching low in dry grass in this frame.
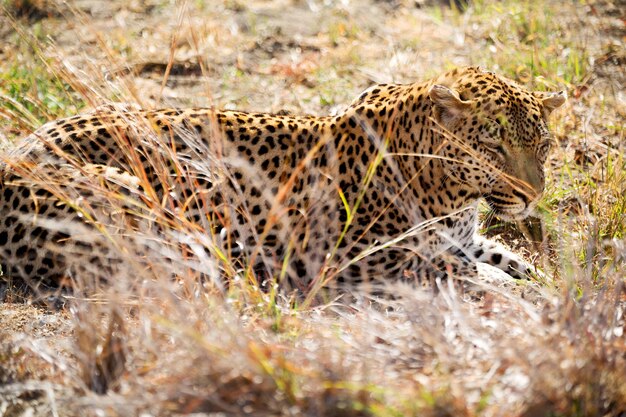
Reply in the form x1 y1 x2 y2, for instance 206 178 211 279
0 66 566 292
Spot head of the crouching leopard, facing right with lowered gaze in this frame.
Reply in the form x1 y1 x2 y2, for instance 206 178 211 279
429 67 566 219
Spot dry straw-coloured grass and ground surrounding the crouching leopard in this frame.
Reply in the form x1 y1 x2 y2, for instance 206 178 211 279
0 0 626 416
